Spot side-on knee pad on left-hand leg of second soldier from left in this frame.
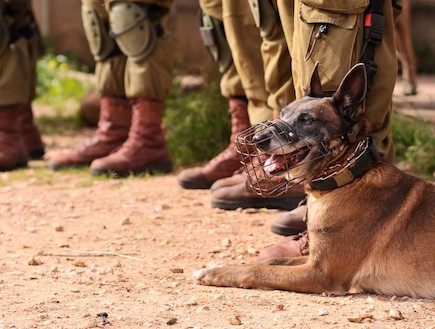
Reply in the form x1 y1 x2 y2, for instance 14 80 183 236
82 4 119 62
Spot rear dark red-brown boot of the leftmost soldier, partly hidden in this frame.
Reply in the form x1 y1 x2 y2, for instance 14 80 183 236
18 104 45 160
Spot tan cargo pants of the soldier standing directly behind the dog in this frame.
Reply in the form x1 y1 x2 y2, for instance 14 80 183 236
277 0 400 162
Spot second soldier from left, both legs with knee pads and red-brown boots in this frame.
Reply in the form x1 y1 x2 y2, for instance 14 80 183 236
49 0 172 176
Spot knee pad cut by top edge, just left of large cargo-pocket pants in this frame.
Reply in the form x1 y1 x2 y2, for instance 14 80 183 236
248 0 278 37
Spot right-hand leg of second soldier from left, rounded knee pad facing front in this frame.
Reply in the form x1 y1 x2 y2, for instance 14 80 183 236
91 1 173 176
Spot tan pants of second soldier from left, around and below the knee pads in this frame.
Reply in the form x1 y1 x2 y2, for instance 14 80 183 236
82 0 173 101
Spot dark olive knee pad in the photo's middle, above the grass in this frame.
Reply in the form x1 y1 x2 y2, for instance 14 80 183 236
199 11 233 73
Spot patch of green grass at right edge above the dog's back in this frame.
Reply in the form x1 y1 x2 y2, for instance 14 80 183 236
391 114 435 177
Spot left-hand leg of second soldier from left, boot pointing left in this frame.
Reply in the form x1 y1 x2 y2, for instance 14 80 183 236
49 0 131 170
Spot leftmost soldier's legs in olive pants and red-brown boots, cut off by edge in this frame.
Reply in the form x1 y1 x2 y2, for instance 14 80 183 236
0 0 45 171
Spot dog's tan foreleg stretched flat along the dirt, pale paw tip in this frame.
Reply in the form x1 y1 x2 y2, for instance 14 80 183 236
193 263 336 293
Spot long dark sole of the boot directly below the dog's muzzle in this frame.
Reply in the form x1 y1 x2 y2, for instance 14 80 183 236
211 194 305 210
